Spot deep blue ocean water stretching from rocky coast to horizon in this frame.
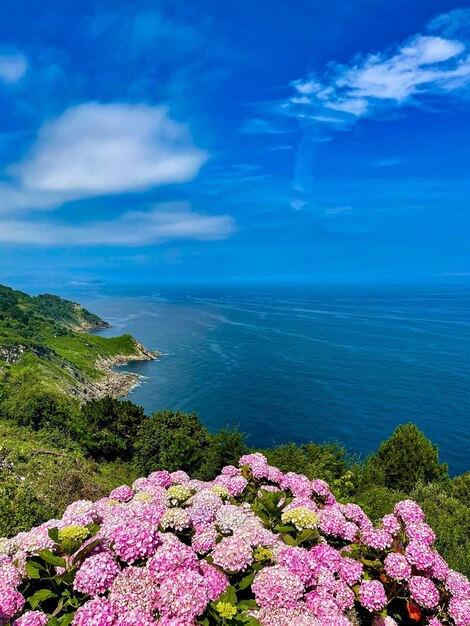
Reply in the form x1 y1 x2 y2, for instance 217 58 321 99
74 286 470 474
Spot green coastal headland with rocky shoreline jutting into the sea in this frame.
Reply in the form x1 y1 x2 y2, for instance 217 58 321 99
0 285 153 398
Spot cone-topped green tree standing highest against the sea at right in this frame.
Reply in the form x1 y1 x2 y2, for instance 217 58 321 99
364 423 448 492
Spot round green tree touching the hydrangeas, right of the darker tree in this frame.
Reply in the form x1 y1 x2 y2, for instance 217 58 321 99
134 411 213 478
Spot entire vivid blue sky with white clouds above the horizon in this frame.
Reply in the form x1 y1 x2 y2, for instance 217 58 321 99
0 0 470 286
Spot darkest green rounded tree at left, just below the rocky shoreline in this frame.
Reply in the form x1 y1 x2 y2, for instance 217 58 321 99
73 397 145 461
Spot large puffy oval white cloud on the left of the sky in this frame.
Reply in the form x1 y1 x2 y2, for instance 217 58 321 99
10 102 208 199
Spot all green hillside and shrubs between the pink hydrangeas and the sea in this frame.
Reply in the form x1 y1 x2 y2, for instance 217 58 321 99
0 287 470 574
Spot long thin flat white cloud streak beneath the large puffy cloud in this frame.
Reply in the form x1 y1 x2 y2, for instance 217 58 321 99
0 203 237 247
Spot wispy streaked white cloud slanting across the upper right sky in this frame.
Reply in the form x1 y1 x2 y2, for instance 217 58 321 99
287 11 470 125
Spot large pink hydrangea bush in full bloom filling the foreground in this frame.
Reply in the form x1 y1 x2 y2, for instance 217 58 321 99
0 454 470 626
